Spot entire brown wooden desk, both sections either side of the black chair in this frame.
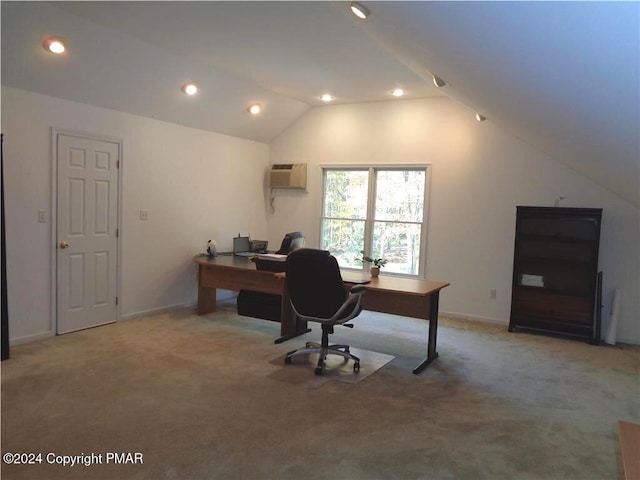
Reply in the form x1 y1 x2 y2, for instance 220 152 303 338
193 256 449 374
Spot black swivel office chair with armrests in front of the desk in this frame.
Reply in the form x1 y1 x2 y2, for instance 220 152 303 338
284 248 366 375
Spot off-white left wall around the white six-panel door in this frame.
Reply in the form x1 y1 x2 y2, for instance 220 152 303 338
2 87 269 344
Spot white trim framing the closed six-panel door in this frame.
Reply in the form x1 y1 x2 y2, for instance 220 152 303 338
49 127 124 336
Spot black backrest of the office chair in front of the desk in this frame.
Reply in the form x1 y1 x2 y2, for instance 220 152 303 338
286 248 348 318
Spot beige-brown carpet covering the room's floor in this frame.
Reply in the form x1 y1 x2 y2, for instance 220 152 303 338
1 305 640 480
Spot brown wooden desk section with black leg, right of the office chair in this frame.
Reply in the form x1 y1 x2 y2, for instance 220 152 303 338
343 273 449 374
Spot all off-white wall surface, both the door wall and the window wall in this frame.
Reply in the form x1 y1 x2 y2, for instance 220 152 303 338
2 87 640 344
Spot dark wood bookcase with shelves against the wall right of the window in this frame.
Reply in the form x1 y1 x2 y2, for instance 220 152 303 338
509 206 602 344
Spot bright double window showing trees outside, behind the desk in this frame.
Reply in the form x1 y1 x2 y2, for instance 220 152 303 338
320 166 428 276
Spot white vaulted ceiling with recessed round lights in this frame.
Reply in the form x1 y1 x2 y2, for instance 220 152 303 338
1 1 640 206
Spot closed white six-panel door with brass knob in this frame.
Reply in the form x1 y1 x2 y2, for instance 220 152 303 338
56 133 120 333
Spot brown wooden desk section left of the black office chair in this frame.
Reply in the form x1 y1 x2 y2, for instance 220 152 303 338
193 255 311 343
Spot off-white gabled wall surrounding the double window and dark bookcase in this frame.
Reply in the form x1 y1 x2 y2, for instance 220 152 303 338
267 98 640 344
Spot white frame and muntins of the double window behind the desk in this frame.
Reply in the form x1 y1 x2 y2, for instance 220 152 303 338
319 163 431 279
